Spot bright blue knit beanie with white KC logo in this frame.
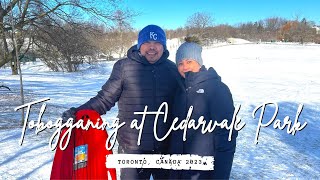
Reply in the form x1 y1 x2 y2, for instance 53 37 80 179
137 25 166 49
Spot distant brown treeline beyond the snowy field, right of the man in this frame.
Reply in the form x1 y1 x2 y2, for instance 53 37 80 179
167 17 320 44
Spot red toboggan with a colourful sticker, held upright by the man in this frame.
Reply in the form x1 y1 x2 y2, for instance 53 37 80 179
50 110 116 180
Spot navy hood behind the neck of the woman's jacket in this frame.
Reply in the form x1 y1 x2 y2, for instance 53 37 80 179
185 65 221 87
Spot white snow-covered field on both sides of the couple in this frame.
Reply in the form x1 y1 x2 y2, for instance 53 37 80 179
0 44 320 179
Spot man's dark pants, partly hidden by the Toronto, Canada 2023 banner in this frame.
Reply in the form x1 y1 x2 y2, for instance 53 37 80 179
118 146 169 180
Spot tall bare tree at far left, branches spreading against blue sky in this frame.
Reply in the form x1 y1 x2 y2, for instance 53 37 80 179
0 0 132 74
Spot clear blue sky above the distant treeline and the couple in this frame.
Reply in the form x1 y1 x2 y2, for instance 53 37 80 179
124 0 320 29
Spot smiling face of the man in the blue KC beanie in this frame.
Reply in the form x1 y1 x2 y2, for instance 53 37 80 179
140 41 163 64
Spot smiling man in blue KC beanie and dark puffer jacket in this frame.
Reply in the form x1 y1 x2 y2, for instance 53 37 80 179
63 25 178 179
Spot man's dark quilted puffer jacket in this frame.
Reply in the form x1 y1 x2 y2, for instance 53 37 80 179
77 46 178 152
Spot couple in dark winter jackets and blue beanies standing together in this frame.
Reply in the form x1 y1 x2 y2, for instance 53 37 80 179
63 25 237 179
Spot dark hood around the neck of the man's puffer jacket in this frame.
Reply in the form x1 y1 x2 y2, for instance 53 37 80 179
127 45 169 65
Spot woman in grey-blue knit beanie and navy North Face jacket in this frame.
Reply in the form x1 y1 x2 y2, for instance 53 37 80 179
170 39 237 179
